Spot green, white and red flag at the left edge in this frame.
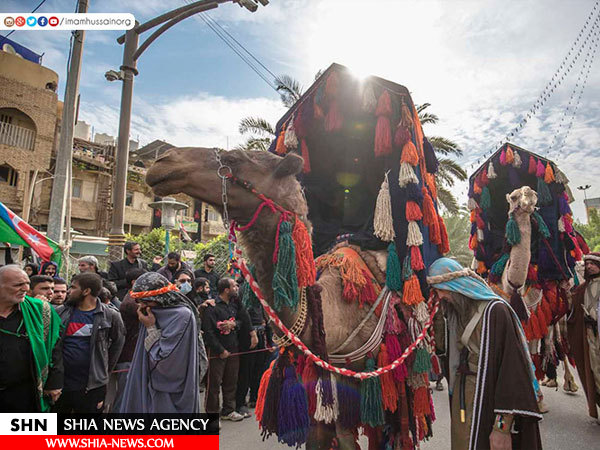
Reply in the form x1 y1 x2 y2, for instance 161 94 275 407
0 202 62 269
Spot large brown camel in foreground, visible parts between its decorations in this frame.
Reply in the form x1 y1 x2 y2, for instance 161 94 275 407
146 147 386 449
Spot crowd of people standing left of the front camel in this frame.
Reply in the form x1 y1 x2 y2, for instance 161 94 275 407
0 242 275 421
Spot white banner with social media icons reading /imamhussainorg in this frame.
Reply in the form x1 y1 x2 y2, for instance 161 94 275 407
0 13 135 31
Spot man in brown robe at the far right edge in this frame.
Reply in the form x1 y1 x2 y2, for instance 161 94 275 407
567 252 600 423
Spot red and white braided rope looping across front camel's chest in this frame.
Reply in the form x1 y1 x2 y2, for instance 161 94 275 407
235 259 439 380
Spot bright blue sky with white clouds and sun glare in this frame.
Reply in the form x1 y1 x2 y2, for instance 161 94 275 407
0 0 600 222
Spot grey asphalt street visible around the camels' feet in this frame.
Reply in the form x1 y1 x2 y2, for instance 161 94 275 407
220 371 600 450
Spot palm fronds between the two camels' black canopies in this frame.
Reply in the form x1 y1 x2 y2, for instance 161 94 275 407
416 103 467 214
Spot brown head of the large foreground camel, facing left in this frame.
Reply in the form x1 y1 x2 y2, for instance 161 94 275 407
146 147 307 223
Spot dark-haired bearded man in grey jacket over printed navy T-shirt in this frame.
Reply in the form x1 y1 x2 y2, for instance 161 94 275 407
56 272 125 414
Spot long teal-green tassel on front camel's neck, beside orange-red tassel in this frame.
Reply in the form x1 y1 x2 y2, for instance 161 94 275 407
273 221 298 311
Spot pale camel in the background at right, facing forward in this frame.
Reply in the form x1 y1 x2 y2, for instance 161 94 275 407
501 186 578 396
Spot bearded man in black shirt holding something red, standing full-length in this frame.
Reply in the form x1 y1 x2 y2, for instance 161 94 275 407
202 278 258 422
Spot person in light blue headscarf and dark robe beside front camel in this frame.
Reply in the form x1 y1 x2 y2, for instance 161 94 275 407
427 258 542 450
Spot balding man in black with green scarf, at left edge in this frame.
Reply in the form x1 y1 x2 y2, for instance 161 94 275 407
0 264 63 412
